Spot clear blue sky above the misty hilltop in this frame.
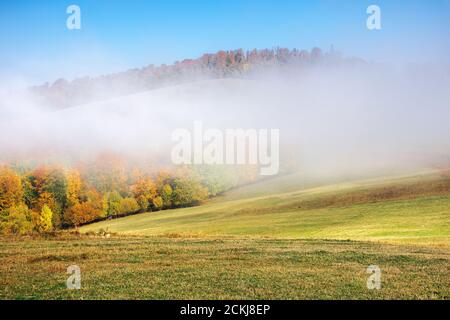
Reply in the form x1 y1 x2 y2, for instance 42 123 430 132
0 0 450 85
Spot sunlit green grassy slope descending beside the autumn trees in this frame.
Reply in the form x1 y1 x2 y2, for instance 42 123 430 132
81 171 450 245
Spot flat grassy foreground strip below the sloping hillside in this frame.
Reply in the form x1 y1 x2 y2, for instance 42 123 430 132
0 236 450 299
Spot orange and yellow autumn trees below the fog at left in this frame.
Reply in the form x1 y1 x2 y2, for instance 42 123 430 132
0 156 256 234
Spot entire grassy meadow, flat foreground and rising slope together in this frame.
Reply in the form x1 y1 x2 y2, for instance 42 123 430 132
0 172 450 299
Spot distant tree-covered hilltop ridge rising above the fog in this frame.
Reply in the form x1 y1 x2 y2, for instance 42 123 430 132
30 48 362 109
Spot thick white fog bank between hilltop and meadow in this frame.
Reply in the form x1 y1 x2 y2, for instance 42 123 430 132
0 64 450 178
